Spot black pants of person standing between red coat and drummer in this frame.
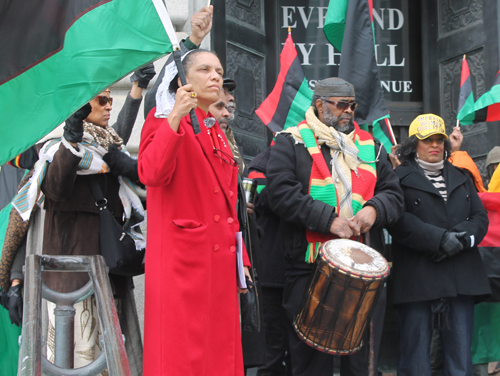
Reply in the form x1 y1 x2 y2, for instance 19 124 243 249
257 287 292 376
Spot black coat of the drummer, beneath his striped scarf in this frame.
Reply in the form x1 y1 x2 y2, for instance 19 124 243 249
266 133 403 273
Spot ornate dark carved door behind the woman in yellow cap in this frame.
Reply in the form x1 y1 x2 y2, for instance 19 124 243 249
422 0 500 172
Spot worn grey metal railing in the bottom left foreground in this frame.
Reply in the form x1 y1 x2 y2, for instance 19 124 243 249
18 254 131 376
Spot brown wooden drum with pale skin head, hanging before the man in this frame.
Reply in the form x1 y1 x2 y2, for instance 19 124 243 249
294 239 389 355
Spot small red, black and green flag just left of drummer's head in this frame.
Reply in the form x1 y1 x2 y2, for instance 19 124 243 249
255 33 313 132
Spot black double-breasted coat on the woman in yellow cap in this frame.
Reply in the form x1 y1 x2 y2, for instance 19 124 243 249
388 160 490 304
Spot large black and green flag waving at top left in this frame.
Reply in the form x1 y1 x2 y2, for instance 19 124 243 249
0 0 177 164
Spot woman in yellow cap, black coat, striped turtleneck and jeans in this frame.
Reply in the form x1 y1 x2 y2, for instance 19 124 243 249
389 114 490 376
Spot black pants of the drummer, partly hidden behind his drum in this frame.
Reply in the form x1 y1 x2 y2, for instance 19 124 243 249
283 274 386 376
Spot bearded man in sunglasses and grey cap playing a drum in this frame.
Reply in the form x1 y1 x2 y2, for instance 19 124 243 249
267 77 403 376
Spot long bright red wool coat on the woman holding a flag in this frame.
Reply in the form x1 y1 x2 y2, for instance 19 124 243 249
139 109 249 376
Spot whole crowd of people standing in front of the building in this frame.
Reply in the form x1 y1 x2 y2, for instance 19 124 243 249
0 3 500 376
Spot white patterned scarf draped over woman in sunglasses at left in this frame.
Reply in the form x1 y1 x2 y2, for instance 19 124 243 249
12 132 146 250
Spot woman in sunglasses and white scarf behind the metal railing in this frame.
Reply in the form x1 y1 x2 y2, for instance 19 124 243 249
0 64 154 374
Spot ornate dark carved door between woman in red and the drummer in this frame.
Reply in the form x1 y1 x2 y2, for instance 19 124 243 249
212 0 277 162
